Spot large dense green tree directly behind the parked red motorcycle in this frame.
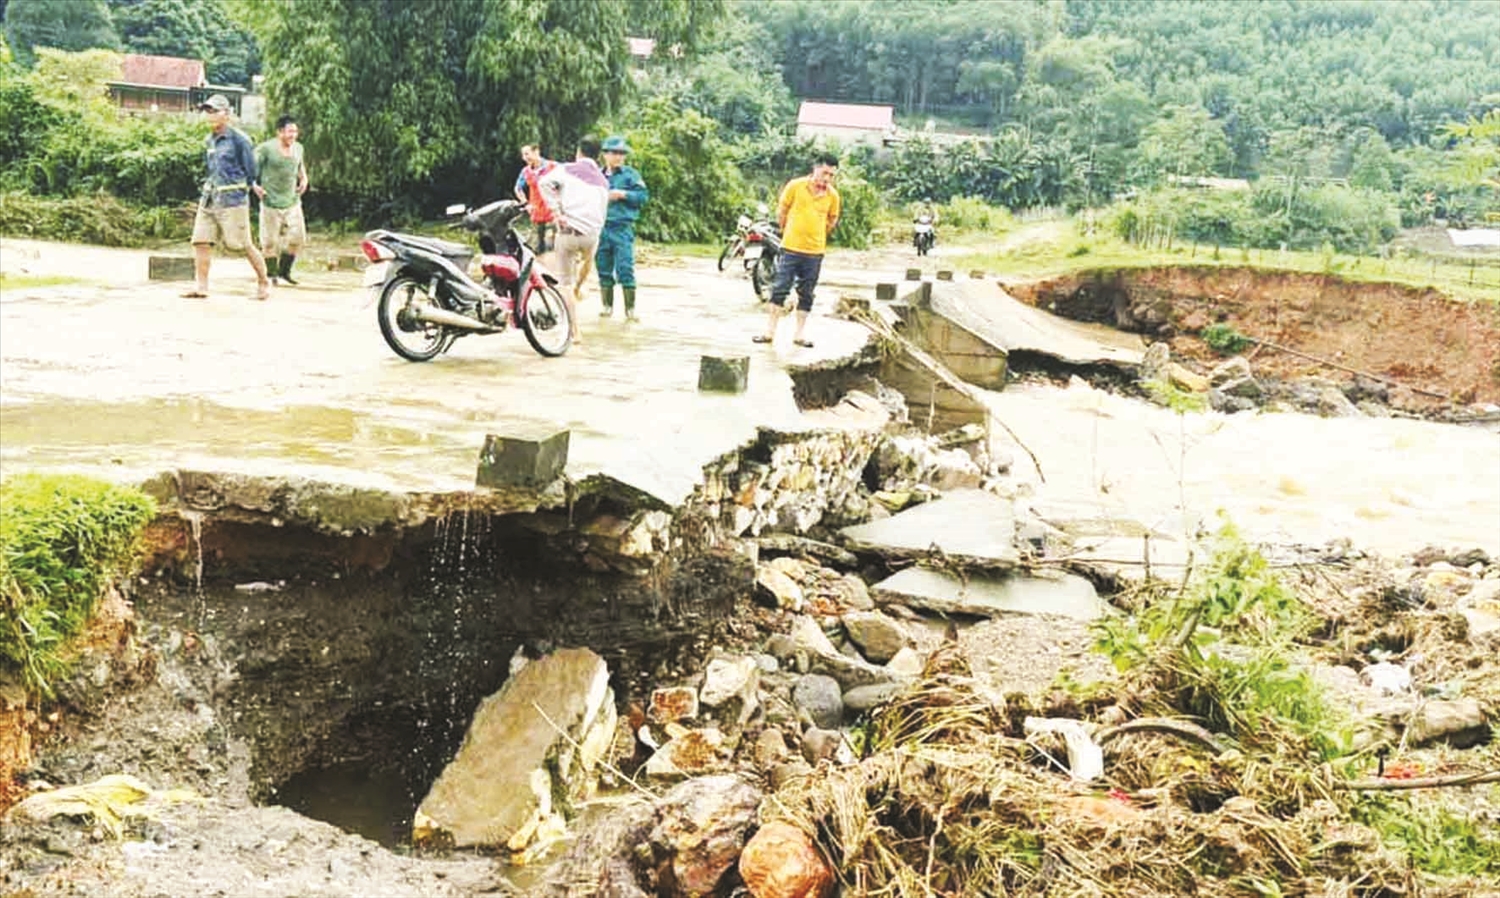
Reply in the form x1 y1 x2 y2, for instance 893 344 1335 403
234 0 722 219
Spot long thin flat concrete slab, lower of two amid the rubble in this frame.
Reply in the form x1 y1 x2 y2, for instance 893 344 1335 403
873 568 1109 621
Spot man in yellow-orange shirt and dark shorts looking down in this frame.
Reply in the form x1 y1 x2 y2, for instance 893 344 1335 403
755 153 842 348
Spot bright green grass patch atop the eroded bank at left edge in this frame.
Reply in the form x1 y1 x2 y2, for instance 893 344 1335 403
0 474 156 696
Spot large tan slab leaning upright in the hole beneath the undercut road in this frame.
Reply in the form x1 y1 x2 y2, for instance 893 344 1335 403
413 649 617 852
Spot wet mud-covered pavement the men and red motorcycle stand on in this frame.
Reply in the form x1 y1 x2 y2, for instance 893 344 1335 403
0 240 867 502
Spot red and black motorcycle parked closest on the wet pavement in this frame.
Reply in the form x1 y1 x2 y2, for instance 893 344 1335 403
360 199 573 361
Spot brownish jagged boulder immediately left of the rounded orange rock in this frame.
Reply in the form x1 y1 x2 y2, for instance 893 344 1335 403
650 775 761 898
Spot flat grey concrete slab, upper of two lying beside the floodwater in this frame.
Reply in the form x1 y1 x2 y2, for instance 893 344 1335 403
840 490 1020 567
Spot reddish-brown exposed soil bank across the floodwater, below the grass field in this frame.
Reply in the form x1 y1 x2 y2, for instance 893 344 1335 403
1005 265 1500 405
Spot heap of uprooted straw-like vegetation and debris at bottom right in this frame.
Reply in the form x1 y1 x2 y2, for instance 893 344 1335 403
761 529 1500 898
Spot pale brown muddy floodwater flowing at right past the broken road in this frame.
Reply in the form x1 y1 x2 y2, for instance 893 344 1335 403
987 381 1500 563
